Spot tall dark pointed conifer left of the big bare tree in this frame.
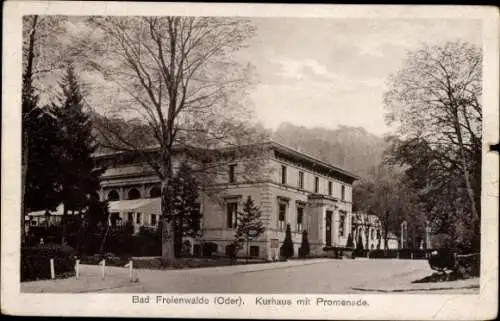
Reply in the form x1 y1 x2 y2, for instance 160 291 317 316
57 65 100 241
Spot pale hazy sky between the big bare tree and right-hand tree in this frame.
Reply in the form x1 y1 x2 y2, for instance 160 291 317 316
238 18 481 135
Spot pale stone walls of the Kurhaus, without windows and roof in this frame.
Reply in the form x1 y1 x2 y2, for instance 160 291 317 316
94 144 360 259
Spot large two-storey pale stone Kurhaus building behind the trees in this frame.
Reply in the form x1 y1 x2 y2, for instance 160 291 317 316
96 141 357 260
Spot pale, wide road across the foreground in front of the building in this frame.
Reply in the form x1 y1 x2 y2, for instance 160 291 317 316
23 259 480 294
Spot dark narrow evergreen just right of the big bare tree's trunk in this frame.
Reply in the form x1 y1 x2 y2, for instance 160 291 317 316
170 162 201 257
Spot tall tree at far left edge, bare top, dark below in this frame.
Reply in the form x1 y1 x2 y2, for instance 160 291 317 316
21 15 74 237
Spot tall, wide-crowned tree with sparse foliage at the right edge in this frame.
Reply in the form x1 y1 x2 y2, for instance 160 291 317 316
385 42 482 250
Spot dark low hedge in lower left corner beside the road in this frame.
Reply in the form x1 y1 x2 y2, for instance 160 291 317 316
21 244 76 281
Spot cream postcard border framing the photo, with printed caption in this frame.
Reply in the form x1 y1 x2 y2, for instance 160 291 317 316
1 1 499 320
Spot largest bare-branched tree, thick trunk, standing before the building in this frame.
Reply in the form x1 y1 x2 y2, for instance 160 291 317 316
72 17 264 264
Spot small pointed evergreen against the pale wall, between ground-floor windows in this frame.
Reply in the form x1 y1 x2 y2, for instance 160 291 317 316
234 196 265 258
